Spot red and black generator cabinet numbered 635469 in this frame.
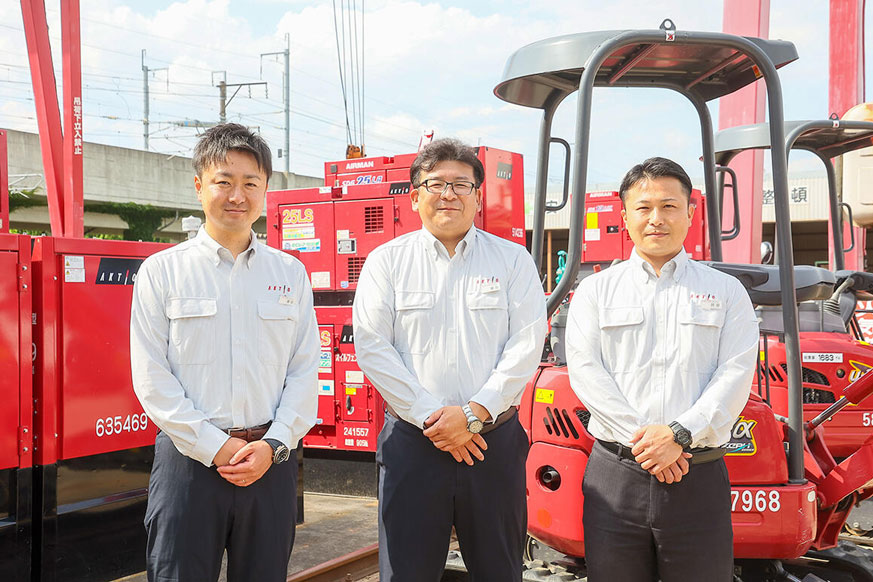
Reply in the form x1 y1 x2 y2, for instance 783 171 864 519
31 237 169 581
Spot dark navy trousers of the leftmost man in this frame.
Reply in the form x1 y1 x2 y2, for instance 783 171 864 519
145 432 297 582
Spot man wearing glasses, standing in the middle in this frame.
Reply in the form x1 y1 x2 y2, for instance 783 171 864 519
354 139 546 582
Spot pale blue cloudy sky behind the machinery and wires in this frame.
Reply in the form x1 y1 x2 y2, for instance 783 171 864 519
0 0 870 190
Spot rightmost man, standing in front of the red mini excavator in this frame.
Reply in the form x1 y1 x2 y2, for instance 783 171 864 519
567 158 758 582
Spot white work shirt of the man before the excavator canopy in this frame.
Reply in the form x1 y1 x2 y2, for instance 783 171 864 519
566 250 758 447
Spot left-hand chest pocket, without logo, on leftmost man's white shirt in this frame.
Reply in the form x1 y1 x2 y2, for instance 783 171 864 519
167 297 218 364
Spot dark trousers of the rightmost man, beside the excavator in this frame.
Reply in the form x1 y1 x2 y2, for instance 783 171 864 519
582 443 733 582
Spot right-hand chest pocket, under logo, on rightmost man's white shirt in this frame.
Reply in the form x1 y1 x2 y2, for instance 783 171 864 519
679 303 725 374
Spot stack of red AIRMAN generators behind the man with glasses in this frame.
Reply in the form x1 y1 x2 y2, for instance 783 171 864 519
267 147 525 452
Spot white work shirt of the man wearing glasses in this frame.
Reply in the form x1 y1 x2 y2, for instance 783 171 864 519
354 227 546 427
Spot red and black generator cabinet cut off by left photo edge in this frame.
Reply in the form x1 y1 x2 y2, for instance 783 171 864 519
0 233 33 580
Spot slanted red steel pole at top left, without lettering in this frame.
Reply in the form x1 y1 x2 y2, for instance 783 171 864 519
21 0 64 236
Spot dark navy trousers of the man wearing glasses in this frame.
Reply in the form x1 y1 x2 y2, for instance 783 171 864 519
376 413 528 582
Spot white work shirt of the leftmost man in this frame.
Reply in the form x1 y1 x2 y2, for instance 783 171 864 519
130 227 321 466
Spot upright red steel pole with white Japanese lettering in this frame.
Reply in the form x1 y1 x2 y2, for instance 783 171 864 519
61 0 85 238
